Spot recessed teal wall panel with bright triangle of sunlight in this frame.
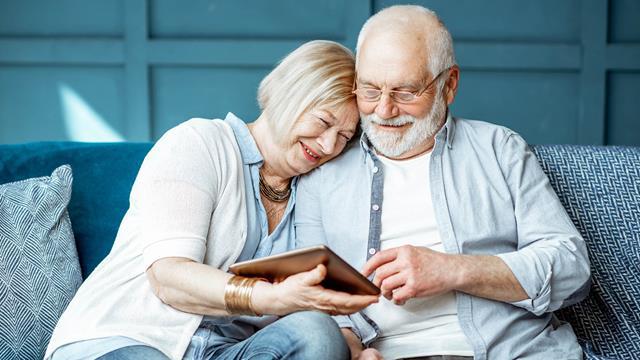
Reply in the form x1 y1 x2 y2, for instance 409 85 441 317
0 64 126 143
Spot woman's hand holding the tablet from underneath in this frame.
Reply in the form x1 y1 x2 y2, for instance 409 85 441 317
251 265 378 315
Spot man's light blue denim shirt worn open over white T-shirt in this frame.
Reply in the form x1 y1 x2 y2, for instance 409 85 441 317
295 116 590 359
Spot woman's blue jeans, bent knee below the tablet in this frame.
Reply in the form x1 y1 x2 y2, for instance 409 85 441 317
100 311 349 360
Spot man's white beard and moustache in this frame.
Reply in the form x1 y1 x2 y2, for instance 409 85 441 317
360 94 447 158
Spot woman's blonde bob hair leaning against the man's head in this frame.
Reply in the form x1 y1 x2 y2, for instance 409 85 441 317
258 40 355 144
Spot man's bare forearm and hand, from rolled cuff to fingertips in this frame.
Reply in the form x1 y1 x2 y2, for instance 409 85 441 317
362 245 528 305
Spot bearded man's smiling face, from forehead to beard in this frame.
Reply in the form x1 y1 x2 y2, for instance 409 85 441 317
356 34 447 158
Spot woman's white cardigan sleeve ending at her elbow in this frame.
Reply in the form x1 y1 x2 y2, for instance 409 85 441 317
130 124 217 269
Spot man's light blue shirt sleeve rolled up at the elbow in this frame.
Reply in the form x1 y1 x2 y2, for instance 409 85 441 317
497 132 590 315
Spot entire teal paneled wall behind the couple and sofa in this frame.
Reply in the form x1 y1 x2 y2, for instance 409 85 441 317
0 0 640 145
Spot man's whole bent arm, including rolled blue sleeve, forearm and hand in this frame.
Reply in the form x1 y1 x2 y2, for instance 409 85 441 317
363 132 590 315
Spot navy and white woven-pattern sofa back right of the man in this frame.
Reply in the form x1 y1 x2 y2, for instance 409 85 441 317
533 145 640 359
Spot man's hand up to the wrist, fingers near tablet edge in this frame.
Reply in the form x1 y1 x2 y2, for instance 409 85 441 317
362 245 460 305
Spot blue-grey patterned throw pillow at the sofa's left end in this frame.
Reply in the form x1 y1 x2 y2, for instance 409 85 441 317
0 165 82 359
